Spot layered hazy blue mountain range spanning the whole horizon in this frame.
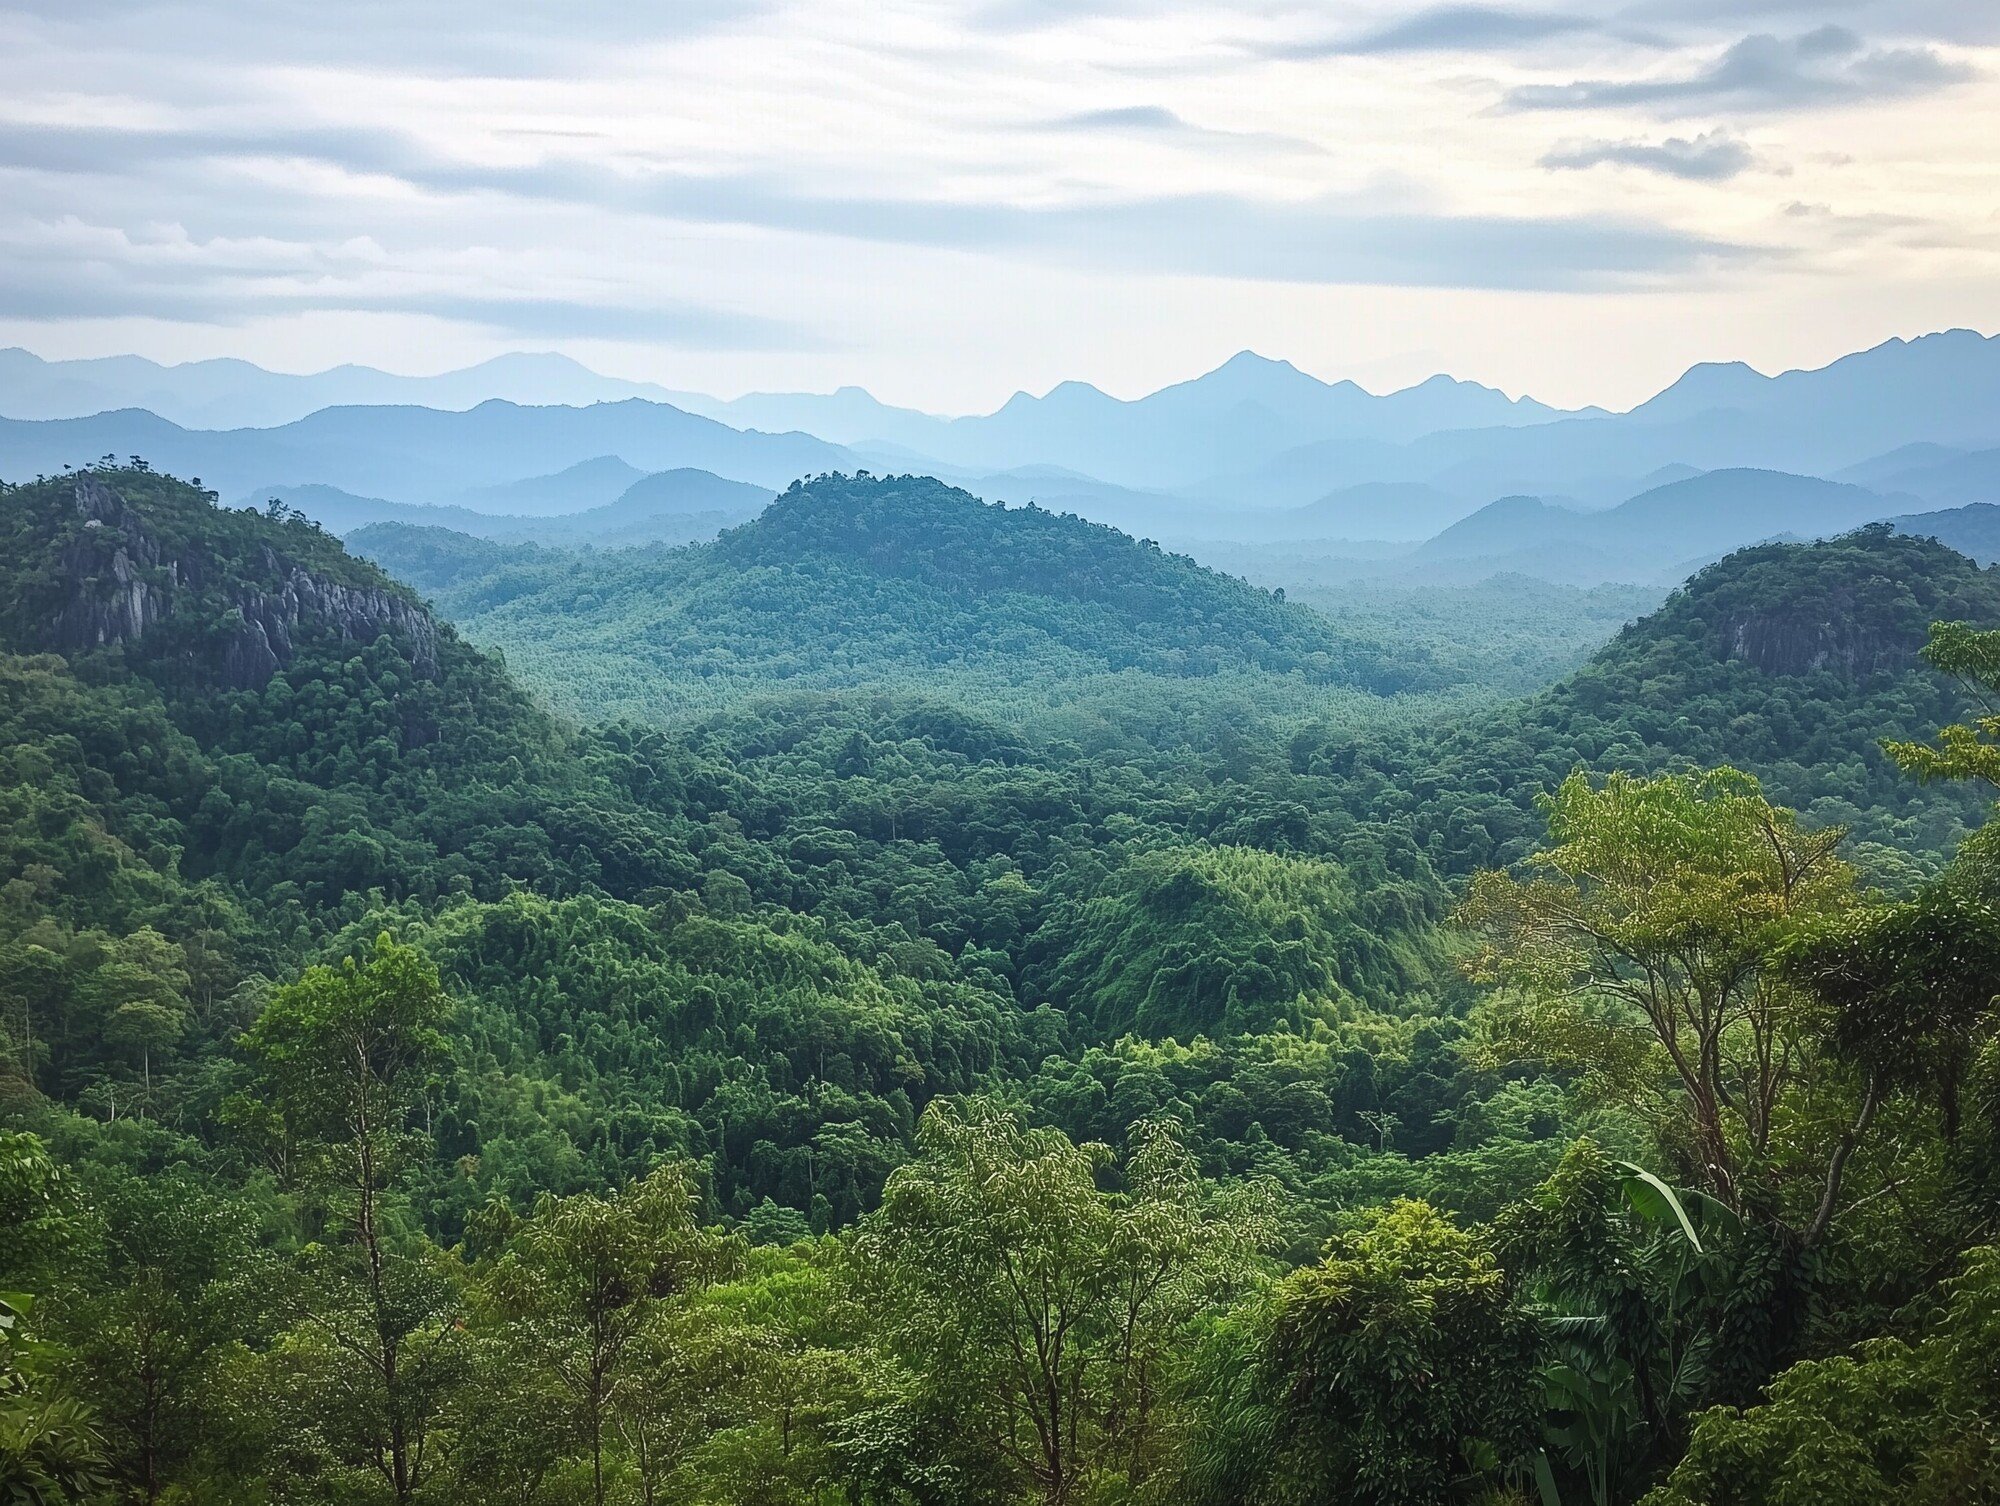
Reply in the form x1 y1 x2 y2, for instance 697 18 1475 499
0 330 2000 582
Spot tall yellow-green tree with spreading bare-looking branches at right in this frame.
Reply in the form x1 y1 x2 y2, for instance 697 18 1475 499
1458 768 1856 1248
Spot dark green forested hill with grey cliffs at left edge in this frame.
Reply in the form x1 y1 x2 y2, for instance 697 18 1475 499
0 470 712 916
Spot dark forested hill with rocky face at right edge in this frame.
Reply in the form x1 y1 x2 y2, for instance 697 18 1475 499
1292 526 2000 874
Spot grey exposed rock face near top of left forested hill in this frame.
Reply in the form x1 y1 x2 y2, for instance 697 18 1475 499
50 476 438 688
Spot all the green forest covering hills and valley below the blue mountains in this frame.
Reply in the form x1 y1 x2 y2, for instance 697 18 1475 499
0 468 2000 1506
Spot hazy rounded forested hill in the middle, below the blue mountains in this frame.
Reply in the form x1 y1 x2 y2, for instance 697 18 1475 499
354 474 1442 720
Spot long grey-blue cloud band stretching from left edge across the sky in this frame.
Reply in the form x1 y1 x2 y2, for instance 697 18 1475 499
0 126 1764 288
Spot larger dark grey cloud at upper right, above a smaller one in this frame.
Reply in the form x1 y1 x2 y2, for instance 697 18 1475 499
1506 26 1976 114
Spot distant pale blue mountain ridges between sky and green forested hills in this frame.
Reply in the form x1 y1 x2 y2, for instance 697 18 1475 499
0 330 2000 552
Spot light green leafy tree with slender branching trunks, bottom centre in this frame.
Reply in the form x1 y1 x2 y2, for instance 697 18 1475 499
856 1098 1272 1506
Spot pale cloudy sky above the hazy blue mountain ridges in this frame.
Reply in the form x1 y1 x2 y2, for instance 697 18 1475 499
0 0 2000 412
